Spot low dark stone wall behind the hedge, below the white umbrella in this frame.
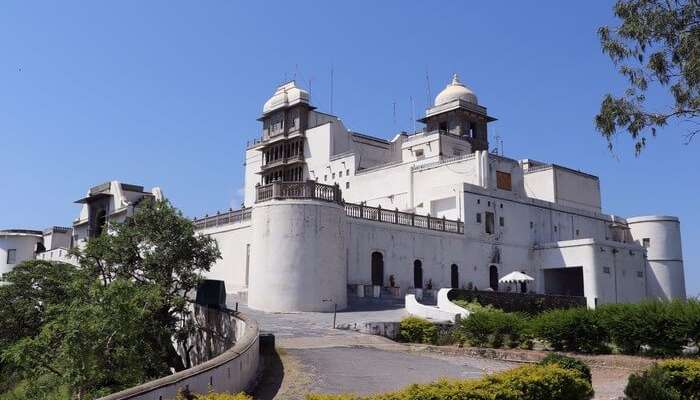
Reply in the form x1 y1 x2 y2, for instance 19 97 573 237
447 289 586 314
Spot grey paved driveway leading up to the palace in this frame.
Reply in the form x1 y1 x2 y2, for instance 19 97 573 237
229 298 629 400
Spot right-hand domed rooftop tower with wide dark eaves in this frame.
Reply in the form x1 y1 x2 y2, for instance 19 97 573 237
419 74 496 152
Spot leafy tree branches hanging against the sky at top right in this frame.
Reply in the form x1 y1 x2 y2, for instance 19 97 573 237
595 0 700 155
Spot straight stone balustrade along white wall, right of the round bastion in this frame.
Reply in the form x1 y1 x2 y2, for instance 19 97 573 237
345 203 464 233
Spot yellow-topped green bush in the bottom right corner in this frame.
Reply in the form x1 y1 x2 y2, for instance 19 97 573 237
625 359 700 400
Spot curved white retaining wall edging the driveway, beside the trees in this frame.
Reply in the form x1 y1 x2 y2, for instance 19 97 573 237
99 313 260 400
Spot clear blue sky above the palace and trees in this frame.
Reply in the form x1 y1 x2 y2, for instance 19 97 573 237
0 1 700 295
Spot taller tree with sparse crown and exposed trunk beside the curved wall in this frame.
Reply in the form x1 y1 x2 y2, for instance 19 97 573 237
73 200 221 371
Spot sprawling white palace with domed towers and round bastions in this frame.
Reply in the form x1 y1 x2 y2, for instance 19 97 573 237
0 76 685 312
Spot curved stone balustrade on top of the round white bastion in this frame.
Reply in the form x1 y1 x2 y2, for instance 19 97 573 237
255 181 343 203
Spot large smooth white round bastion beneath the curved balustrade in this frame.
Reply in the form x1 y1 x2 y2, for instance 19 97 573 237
248 194 348 312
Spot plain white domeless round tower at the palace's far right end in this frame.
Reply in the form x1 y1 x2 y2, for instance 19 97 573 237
627 215 686 300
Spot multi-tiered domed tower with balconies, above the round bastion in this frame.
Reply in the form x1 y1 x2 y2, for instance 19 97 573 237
258 81 314 184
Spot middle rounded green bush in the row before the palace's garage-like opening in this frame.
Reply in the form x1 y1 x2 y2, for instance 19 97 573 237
530 308 609 353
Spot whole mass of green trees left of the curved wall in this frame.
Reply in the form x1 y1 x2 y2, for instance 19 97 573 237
0 200 220 399
